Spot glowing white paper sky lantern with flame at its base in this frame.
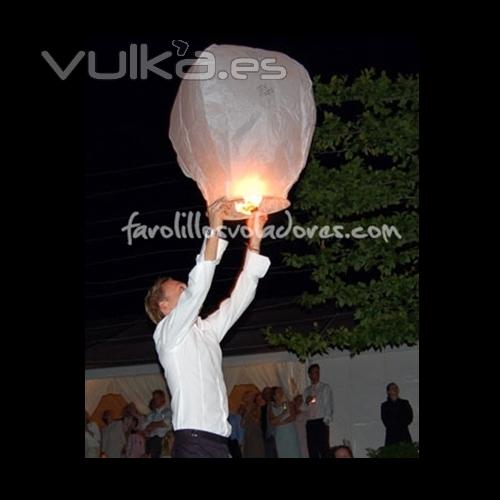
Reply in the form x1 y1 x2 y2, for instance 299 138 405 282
169 45 316 220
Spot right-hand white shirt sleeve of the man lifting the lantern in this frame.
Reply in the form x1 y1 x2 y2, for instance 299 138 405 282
202 250 271 342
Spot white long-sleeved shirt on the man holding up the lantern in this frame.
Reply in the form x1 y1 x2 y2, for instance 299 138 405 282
153 238 271 437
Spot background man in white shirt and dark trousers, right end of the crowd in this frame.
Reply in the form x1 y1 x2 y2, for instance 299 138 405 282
304 364 333 458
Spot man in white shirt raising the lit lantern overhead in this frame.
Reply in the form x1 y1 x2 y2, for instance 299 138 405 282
145 199 270 458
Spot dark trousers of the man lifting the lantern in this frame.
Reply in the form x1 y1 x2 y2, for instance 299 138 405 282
172 429 231 458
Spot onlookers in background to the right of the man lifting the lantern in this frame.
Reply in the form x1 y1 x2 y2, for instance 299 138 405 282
229 364 413 458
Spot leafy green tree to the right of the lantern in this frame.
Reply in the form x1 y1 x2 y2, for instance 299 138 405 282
265 69 419 360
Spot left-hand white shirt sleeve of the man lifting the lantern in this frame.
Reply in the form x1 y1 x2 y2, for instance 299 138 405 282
154 238 227 350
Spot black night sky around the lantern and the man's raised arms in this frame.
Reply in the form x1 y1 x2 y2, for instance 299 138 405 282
82 35 419 348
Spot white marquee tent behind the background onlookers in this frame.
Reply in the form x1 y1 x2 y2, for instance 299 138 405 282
85 347 419 458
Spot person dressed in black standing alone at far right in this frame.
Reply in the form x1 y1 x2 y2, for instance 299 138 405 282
381 382 413 446
